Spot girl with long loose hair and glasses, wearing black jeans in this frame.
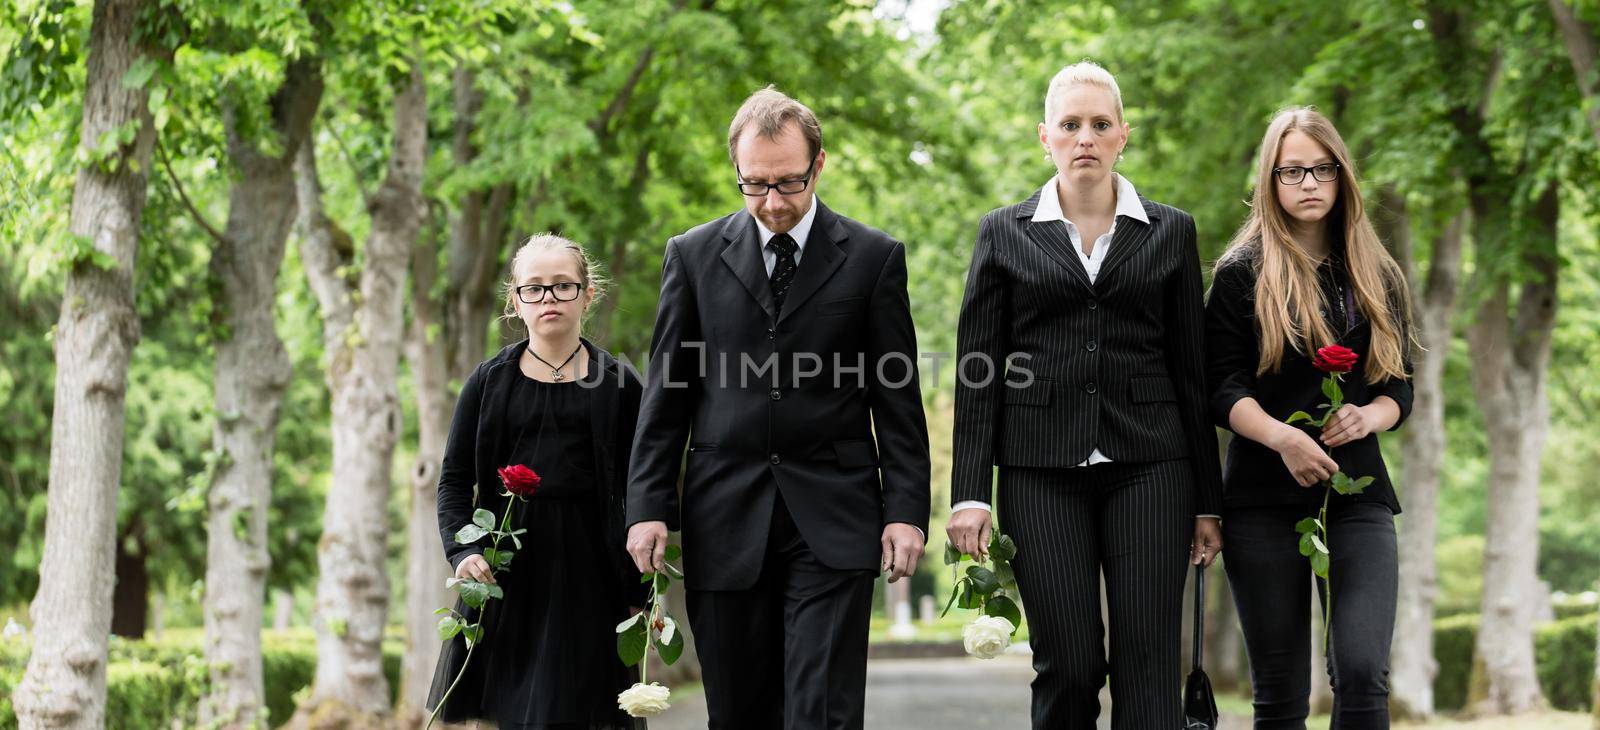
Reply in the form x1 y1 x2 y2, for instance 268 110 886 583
1206 109 1411 728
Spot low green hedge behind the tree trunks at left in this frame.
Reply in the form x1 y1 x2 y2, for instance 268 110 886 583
0 631 403 730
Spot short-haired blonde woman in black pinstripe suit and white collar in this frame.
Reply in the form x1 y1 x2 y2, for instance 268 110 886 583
949 62 1222 730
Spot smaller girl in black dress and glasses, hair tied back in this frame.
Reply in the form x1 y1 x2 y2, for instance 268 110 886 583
427 235 645 730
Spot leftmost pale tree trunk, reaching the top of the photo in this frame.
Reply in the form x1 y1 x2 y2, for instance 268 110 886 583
11 0 171 728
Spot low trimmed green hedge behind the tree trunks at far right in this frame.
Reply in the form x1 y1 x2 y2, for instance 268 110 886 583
1434 613 1597 711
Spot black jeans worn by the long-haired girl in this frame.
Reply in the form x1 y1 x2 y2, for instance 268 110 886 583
1222 503 1398 730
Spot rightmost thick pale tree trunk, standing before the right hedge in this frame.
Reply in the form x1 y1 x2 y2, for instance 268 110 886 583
1467 184 1560 716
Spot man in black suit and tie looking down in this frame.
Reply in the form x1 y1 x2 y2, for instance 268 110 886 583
627 88 930 730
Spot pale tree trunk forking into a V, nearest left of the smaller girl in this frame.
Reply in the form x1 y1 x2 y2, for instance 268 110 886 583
294 59 427 727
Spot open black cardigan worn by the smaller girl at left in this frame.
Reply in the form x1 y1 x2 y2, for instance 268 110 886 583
437 339 645 605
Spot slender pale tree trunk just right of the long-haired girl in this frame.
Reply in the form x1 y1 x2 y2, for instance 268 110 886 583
1389 208 1466 719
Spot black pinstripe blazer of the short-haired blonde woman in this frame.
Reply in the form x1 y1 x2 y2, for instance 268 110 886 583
950 192 1222 514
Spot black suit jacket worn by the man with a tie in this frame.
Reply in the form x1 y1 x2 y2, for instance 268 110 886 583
627 200 930 591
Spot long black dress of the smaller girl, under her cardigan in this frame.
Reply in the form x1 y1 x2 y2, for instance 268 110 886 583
427 373 645 730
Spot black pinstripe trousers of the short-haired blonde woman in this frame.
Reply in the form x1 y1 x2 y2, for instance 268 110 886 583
998 459 1194 730
